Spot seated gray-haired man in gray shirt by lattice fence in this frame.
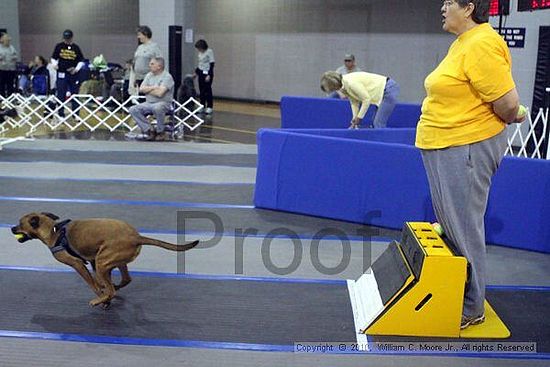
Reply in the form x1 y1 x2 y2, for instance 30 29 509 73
129 57 174 141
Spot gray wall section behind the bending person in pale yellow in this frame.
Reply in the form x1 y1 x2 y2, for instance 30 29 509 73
197 0 452 102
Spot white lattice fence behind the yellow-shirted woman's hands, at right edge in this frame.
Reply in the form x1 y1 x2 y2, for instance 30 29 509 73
506 108 550 159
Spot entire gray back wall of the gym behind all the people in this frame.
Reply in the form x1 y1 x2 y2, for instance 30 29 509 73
14 0 550 105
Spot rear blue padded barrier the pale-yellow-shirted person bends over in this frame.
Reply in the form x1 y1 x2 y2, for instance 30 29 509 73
280 96 421 129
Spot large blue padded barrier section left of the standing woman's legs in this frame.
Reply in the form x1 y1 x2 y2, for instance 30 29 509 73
254 129 440 228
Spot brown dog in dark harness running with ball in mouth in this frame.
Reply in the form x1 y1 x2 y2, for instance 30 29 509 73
11 213 199 307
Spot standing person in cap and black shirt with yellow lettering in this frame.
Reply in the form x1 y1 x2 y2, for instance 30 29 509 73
52 29 84 117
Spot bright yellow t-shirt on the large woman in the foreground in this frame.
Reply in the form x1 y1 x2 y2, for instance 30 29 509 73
416 23 515 149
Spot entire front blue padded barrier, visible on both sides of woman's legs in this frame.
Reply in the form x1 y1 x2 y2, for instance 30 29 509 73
254 129 550 253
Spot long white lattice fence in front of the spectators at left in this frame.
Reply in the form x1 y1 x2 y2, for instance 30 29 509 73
0 94 204 135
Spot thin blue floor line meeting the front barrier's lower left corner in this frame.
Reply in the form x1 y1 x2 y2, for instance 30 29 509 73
0 196 255 209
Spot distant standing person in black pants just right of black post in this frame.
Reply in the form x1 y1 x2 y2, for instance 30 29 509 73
195 40 215 115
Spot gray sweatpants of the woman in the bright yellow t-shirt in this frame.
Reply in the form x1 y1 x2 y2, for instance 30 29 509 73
421 130 507 316
